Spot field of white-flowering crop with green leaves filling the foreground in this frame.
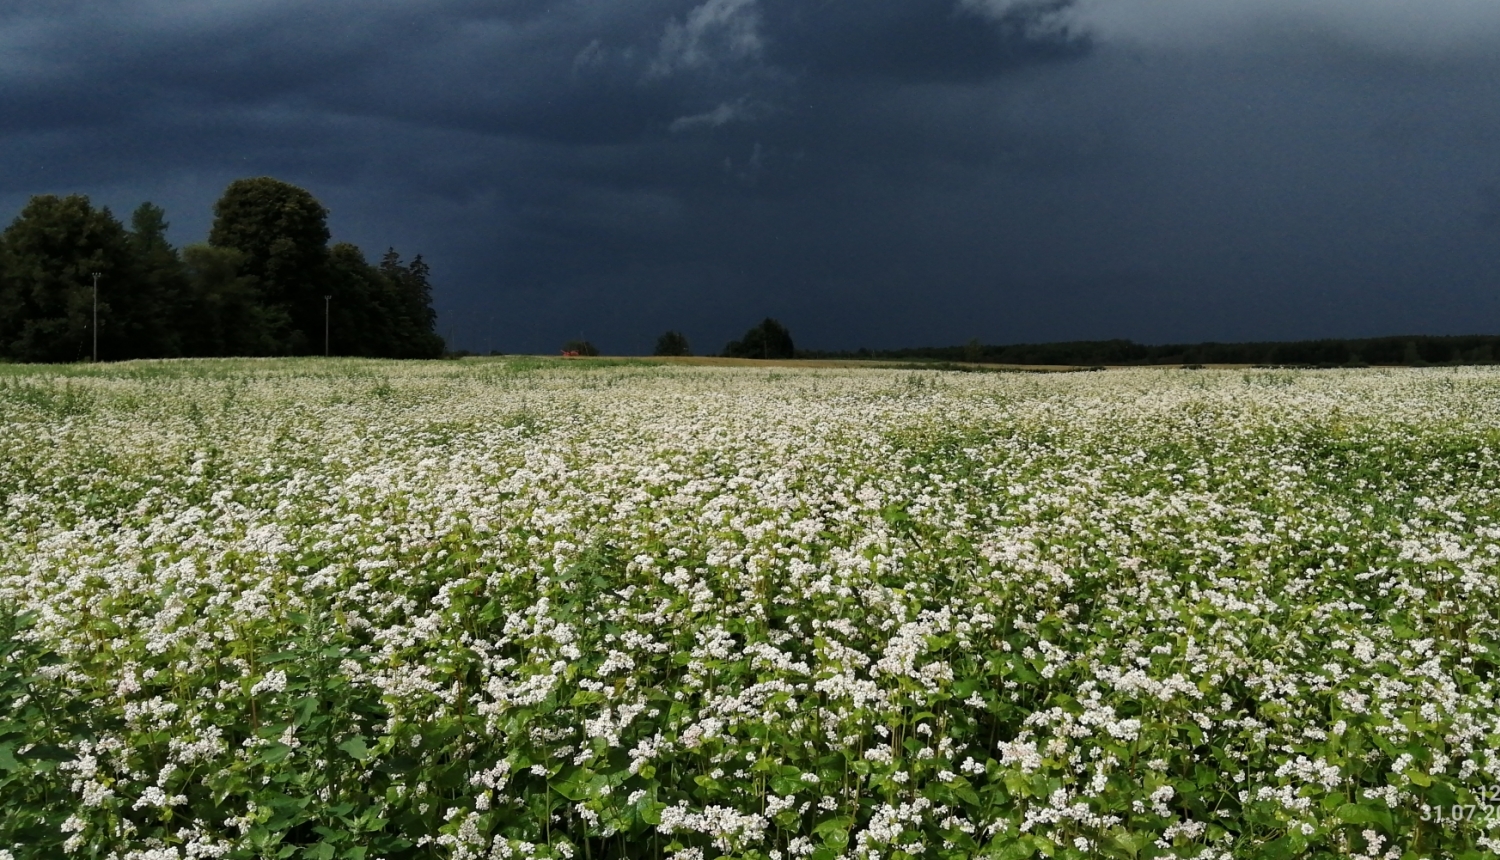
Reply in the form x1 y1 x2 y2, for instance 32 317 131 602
0 359 1500 860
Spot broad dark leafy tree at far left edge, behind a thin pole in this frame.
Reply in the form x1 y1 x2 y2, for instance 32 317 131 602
0 195 140 362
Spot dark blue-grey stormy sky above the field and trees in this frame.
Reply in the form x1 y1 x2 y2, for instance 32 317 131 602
0 0 1500 354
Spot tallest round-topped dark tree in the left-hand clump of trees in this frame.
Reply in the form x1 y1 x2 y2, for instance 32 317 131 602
209 176 329 354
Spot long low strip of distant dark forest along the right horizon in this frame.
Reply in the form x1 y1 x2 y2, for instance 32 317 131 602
797 335 1500 368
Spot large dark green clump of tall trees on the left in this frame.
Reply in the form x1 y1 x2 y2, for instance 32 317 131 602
0 177 444 362
